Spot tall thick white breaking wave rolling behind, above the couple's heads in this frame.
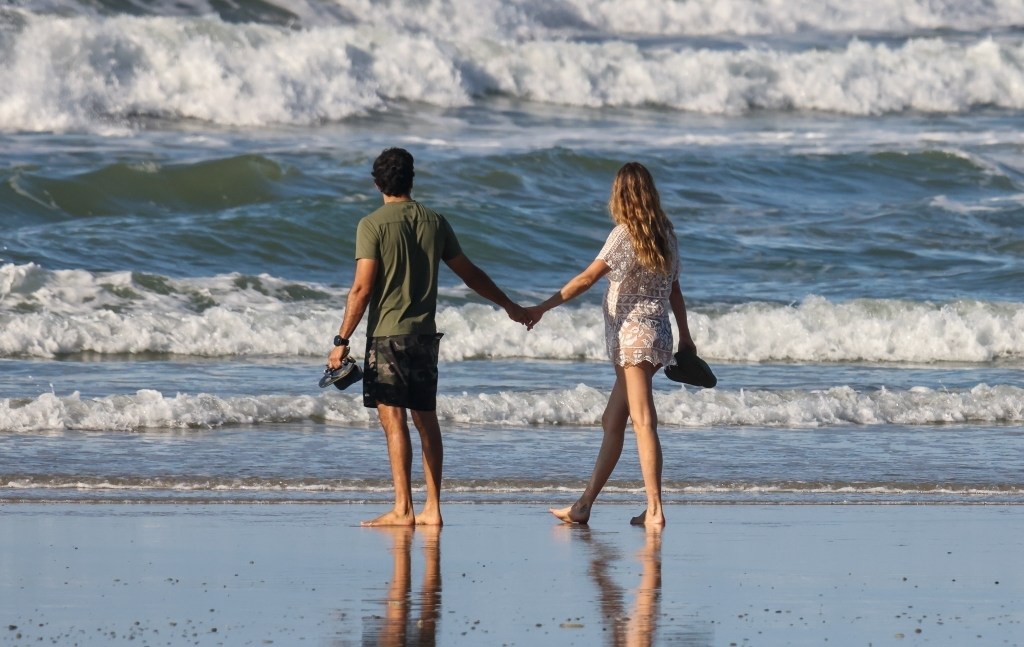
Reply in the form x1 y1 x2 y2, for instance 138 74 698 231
0 8 1024 131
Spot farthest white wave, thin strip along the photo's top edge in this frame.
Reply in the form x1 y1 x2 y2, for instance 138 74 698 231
11 0 1024 39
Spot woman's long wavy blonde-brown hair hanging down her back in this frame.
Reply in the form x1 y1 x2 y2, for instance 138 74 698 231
608 162 676 274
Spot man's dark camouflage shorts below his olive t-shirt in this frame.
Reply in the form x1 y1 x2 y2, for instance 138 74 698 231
362 333 442 412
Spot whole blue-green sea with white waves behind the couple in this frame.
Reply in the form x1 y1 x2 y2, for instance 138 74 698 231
0 0 1024 506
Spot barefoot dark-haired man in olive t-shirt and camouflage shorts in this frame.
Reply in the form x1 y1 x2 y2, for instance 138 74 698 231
328 148 528 525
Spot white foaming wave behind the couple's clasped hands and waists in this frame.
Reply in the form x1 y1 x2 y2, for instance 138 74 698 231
0 264 1024 362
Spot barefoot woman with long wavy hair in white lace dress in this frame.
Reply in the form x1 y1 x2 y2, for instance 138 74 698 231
527 162 696 526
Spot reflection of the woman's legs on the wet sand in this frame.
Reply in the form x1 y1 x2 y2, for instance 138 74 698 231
571 527 662 647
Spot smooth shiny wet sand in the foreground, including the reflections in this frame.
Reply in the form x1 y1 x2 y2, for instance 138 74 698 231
0 504 1024 646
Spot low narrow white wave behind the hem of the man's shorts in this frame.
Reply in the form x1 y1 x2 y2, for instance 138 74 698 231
0 384 1024 433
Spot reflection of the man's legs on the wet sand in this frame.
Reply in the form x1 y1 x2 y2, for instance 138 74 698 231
362 526 441 647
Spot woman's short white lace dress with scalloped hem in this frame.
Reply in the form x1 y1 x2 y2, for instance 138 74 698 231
597 225 679 366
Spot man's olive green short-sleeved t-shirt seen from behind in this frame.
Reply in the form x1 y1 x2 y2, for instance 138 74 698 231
355 201 462 337
